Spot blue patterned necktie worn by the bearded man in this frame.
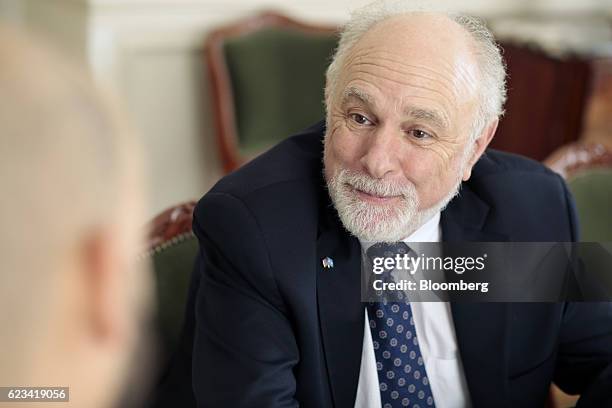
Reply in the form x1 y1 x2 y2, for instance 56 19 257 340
367 243 435 408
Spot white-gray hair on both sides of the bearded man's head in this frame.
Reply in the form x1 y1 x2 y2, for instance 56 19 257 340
325 1 506 140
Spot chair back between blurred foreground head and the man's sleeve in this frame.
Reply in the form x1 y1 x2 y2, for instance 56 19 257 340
145 202 198 368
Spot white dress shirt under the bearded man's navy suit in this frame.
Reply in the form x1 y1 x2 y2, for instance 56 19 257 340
355 213 471 408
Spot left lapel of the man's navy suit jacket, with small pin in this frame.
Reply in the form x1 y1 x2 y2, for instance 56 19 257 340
317 202 364 407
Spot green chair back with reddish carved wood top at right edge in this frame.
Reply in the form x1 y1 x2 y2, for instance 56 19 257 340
545 142 612 242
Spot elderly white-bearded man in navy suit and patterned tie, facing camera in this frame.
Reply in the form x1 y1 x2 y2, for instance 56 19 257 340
169 3 612 408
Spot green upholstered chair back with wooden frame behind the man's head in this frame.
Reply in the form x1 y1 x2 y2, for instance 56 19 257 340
205 12 337 172
